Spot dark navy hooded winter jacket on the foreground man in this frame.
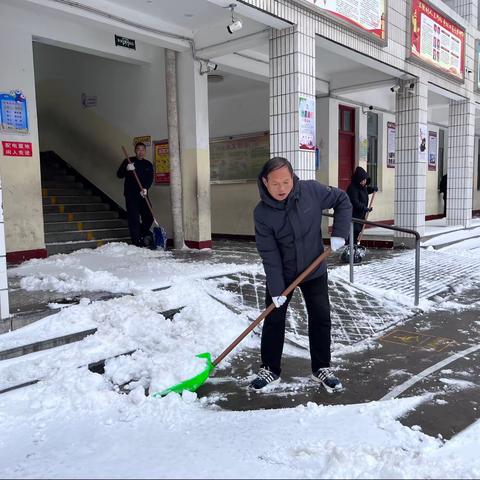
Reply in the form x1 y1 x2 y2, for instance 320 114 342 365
254 175 352 297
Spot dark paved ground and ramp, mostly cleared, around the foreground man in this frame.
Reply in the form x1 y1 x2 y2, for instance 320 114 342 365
3 241 480 438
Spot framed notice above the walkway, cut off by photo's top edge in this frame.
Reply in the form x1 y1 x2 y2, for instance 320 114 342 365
294 0 387 43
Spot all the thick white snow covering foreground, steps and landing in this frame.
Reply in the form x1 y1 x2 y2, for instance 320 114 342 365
0 239 480 478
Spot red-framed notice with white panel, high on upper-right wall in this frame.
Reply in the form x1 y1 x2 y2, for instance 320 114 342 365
410 0 465 81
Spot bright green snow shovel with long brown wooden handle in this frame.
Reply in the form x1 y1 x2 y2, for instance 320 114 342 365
152 247 332 398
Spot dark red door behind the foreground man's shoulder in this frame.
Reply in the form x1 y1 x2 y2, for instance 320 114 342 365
338 105 355 190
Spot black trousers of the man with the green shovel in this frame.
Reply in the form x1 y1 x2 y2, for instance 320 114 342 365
261 273 331 375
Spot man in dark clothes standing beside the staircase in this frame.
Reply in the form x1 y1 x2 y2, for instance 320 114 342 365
117 142 153 247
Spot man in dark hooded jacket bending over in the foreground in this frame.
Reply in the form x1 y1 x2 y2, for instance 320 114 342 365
250 157 352 392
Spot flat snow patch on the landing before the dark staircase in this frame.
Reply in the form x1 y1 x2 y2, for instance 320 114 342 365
8 243 261 293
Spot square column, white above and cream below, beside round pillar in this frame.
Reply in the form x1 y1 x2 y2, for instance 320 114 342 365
177 51 212 248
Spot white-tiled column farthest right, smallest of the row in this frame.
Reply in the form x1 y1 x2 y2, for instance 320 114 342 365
447 100 475 227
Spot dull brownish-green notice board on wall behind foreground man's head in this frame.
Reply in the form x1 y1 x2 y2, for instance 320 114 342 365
210 132 270 183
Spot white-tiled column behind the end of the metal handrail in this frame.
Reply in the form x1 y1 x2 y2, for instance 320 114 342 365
395 81 428 238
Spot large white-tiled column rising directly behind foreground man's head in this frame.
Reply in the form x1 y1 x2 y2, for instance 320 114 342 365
270 18 316 180
